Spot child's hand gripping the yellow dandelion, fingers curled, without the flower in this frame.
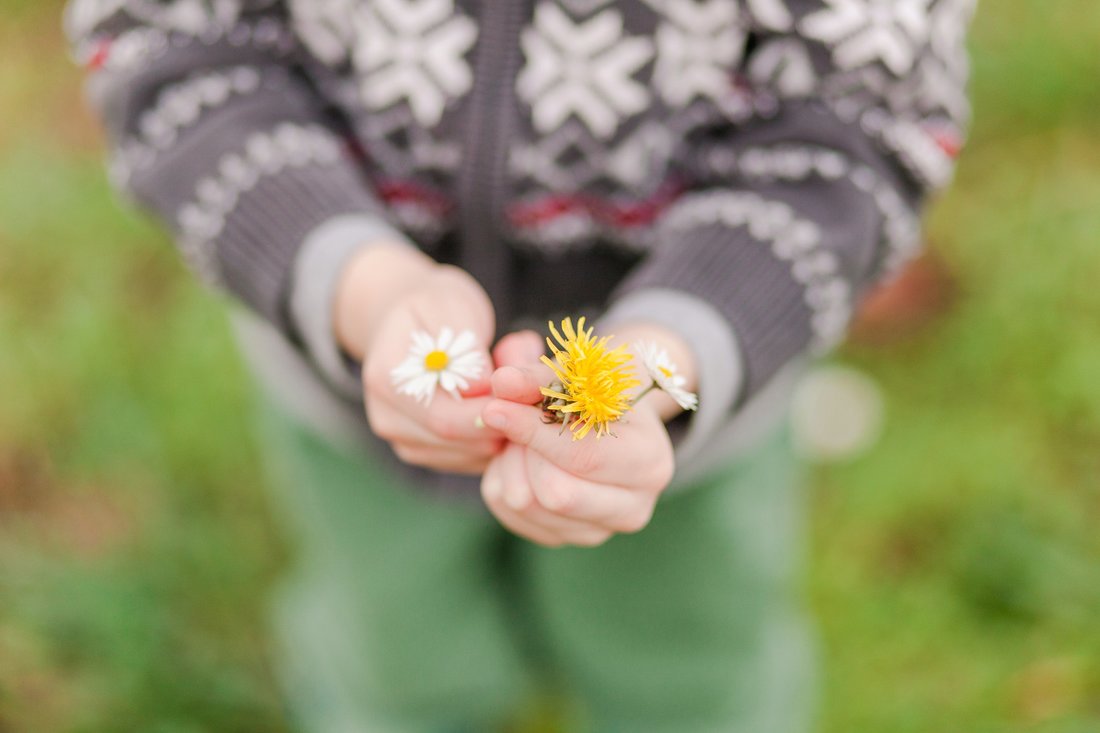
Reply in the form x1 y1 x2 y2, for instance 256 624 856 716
482 363 674 547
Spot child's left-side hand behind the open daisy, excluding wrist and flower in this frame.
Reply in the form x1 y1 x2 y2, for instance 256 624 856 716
363 266 505 474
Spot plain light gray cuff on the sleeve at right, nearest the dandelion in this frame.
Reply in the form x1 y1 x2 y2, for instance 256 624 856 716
600 287 744 483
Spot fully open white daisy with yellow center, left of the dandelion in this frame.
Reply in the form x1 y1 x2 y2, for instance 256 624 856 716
389 328 485 405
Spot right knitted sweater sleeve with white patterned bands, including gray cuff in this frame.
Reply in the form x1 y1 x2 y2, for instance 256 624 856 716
605 0 974 460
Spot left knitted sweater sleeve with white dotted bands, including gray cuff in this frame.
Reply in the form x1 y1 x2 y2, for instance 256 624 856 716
65 0 406 394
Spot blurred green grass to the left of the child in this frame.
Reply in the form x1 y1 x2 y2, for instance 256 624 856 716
0 8 283 733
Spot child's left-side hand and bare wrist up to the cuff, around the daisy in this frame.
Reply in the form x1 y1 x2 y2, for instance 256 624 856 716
336 247 504 474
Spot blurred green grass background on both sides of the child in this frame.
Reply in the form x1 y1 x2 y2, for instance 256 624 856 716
0 0 1100 733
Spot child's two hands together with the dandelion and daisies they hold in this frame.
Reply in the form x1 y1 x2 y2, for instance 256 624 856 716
337 248 697 546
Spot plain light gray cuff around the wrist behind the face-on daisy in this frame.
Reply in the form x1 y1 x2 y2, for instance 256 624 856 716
289 215 414 401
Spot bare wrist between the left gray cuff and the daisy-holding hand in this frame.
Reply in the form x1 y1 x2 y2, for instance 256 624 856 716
332 242 439 361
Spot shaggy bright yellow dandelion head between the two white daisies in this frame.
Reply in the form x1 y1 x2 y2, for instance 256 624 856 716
541 318 640 440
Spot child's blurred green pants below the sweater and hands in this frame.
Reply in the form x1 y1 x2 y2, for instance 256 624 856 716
257 405 813 733
